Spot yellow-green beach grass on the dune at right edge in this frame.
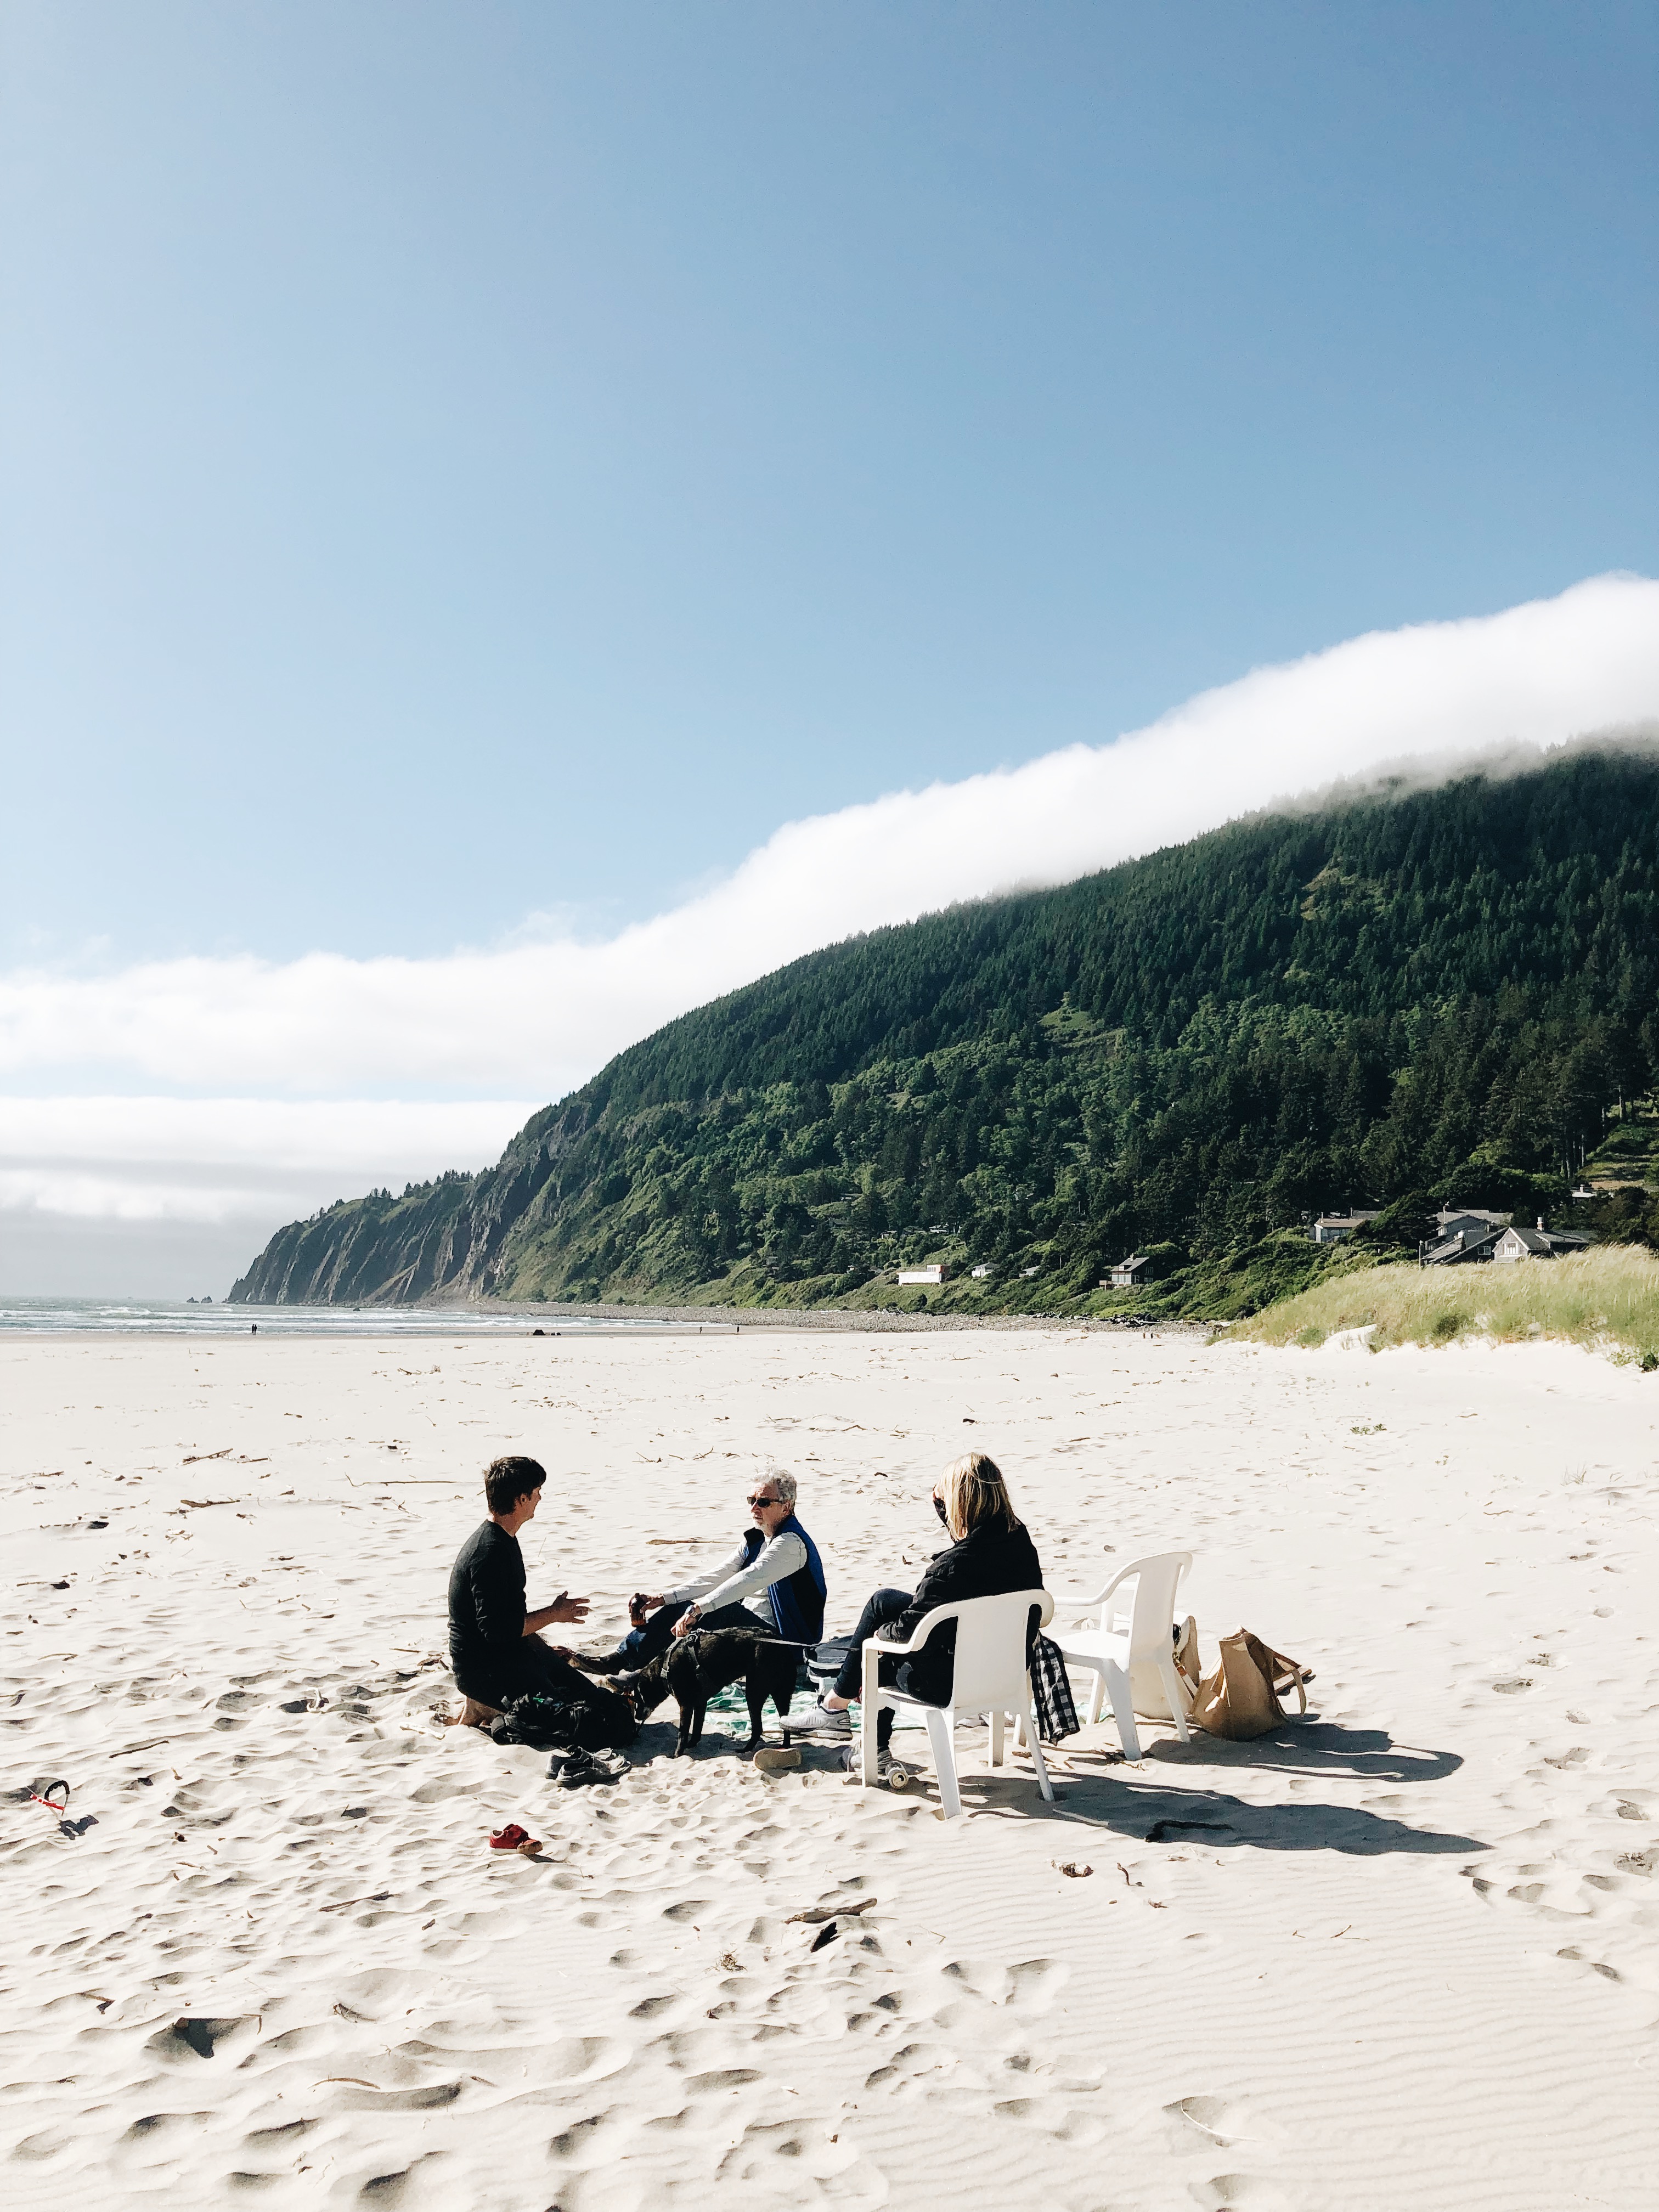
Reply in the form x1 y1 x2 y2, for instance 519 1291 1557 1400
1230 1245 1659 1367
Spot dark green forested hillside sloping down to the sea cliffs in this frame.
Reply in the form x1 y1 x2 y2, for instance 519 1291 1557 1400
232 750 1659 1312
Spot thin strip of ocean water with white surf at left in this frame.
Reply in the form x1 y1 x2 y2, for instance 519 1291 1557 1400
0 1299 732 1336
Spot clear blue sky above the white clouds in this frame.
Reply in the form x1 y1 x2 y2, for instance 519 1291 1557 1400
0 0 1659 962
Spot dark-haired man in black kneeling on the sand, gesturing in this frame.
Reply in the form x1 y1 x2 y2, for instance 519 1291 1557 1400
449 1458 591 1723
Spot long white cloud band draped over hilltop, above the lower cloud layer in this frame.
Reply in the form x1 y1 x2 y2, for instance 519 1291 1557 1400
0 577 1659 1099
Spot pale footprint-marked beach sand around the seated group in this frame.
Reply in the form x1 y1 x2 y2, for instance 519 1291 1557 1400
0 1334 1659 2212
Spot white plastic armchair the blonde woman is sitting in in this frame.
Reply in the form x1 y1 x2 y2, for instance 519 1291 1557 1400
858 1590 1057 1820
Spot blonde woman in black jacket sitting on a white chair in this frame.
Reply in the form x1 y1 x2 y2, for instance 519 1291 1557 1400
789 1451 1042 1768
